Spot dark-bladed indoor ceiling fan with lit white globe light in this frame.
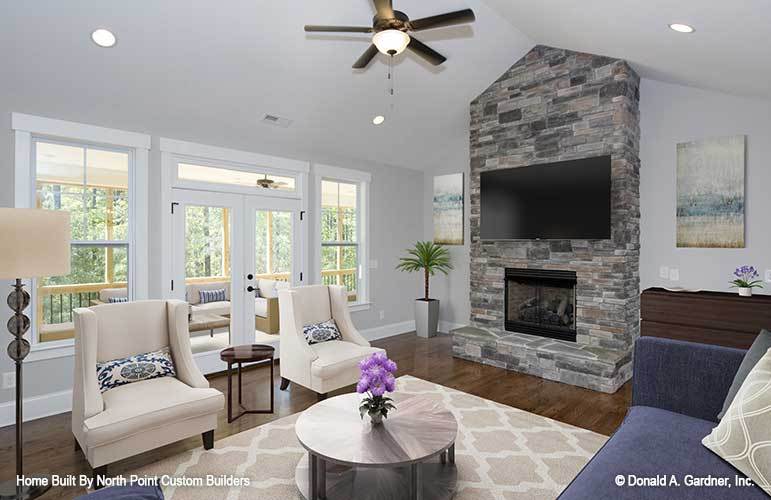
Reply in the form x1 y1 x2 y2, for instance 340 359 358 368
305 0 475 69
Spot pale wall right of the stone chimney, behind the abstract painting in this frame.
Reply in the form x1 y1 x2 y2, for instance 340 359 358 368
640 79 771 293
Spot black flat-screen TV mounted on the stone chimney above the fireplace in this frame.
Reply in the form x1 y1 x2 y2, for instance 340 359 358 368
480 156 610 240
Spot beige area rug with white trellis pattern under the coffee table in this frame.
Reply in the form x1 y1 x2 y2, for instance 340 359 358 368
135 376 607 500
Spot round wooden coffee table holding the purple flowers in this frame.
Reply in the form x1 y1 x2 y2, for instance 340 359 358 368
295 394 458 500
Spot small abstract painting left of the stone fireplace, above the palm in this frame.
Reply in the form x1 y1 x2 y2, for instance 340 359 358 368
434 174 464 245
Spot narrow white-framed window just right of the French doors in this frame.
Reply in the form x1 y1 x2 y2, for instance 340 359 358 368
314 165 369 304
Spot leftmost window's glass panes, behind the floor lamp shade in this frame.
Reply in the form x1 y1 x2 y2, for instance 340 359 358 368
33 139 132 343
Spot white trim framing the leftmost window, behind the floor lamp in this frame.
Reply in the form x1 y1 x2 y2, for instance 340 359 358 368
11 113 151 362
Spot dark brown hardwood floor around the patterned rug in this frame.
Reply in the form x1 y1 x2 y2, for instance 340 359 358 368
0 334 631 499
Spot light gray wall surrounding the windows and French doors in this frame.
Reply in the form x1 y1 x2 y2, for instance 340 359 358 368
0 100 424 414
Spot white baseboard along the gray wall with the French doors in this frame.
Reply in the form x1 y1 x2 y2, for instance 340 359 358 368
0 321 415 427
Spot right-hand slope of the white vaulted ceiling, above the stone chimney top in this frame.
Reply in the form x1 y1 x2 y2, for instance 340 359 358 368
485 0 771 99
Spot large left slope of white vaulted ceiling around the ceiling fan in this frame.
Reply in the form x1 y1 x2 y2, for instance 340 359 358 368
0 0 533 169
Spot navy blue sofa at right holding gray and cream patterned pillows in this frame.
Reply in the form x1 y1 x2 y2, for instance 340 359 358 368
559 337 768 500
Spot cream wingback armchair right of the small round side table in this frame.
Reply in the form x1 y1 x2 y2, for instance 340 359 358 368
278 285 383 399
